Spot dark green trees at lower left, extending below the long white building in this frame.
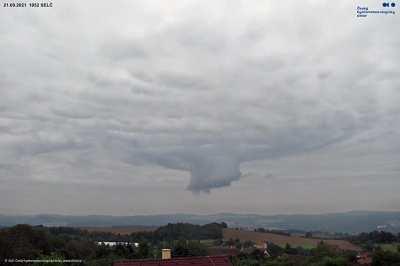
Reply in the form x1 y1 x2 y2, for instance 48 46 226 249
0 225 152 266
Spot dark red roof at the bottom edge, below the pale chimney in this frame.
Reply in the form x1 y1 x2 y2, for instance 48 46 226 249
113 256 232 266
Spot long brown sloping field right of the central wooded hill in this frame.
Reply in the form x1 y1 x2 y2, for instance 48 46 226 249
223 228 361 251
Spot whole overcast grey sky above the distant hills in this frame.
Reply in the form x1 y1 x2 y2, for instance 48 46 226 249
0 0 400 215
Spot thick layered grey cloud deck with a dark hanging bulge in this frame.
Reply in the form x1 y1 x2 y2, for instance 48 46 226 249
0 1 400 214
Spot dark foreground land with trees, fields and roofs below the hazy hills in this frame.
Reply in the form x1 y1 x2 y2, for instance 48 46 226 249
0 222 400 266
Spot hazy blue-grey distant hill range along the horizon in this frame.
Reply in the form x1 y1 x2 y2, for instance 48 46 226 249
0 211 400 233
